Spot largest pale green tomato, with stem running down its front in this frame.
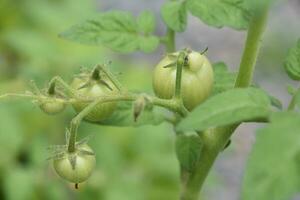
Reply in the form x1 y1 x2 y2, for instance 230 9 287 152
153 51 214 111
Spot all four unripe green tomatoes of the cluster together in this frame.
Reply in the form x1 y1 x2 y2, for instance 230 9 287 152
40 51 213 188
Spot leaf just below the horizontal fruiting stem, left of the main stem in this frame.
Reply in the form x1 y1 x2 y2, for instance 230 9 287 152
97 102 165 126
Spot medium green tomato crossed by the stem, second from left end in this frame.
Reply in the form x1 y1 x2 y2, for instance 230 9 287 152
71 78 118 122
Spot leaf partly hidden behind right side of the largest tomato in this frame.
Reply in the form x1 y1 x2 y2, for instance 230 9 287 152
213 62 237 94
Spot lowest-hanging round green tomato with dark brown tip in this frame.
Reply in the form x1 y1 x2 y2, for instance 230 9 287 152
53 144 96 184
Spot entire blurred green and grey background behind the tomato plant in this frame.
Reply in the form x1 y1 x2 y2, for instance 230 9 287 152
0 0 300 200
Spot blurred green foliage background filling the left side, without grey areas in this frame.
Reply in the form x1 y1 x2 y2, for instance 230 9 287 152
0 0 179 200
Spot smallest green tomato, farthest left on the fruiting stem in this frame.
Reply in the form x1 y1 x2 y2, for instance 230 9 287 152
40 97 66 115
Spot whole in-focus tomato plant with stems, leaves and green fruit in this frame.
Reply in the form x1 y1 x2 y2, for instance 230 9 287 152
0 0 300 200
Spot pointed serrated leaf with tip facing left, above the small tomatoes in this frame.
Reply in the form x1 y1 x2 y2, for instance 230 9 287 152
60 11 158 53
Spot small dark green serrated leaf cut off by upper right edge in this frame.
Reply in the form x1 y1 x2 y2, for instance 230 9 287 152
284 39 300 81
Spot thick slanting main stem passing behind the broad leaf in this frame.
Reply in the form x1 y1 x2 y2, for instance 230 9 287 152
181 6 268 200
